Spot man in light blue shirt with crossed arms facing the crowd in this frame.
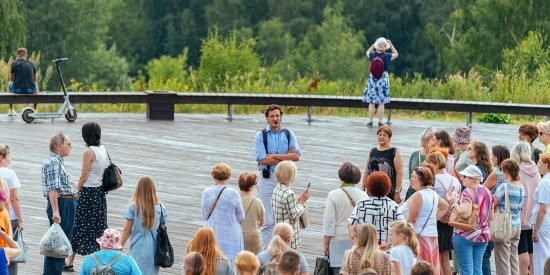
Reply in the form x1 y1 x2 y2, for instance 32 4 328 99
254 105 300 249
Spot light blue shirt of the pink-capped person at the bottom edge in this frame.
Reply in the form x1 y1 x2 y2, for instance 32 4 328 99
80 250 142 275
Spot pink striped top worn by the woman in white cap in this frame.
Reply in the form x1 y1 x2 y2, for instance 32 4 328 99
454 186 493 243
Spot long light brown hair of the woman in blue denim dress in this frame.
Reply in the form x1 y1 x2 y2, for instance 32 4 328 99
130 176 159 231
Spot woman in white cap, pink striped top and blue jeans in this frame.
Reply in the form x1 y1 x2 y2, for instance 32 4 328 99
447 165 493 275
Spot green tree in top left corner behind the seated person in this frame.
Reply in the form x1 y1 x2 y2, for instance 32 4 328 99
0 0 27 58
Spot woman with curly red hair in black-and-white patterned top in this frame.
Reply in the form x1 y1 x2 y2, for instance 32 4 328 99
348 171 404 248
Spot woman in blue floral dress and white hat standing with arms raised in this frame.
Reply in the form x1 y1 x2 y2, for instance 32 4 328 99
363 37 398 127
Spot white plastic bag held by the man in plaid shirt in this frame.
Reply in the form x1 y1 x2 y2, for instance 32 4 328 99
40 223 73 258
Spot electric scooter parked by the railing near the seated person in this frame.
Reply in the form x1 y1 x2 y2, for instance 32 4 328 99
21 57 77 123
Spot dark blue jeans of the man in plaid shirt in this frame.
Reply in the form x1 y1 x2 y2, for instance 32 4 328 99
44 198 76 275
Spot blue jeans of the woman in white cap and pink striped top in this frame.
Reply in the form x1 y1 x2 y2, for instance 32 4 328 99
453 235 487 275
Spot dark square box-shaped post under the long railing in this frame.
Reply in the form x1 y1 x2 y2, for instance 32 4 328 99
145 91 178 120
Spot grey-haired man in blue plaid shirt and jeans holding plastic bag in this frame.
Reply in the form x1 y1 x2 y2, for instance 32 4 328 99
42 132 78 275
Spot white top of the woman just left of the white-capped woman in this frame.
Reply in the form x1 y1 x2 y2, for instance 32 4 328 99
401 188 439 237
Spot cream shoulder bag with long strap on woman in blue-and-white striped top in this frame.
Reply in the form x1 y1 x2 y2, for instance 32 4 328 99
489 182 512 243
